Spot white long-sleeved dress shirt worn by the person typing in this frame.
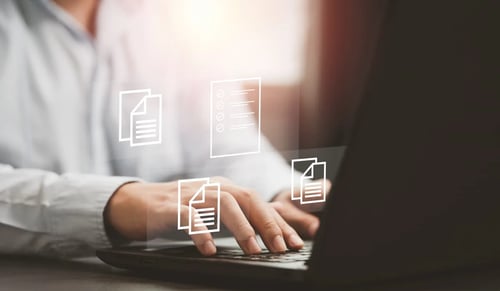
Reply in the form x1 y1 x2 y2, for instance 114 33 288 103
0 0 290 256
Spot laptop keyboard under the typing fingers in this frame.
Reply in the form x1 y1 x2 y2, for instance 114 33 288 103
155 243 312 263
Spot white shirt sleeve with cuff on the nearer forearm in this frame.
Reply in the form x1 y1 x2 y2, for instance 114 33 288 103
0 164 137 255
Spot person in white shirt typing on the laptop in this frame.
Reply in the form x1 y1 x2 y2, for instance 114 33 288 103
0 0 328 256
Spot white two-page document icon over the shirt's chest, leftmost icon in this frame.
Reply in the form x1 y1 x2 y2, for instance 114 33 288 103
118 89 162 147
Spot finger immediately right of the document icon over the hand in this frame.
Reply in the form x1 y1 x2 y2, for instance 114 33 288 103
220 192 261 255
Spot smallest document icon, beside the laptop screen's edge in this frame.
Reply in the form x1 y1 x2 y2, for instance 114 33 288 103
291 158 326 204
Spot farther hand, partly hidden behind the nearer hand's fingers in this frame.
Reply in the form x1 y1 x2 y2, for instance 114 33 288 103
271 180 332 238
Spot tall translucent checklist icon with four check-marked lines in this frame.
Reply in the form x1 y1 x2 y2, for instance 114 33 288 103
210 77 261 158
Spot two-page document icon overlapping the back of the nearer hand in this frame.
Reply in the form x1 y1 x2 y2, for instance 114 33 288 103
177 178 220 235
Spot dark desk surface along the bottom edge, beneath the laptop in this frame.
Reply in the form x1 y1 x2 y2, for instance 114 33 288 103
0 256 500 291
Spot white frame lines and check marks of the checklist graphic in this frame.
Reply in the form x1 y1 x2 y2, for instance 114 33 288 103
210 77 262 159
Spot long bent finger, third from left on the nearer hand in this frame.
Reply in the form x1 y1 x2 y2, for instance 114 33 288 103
222 184 286 253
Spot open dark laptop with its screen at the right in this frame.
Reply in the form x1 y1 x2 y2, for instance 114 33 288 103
97 0 500 286
